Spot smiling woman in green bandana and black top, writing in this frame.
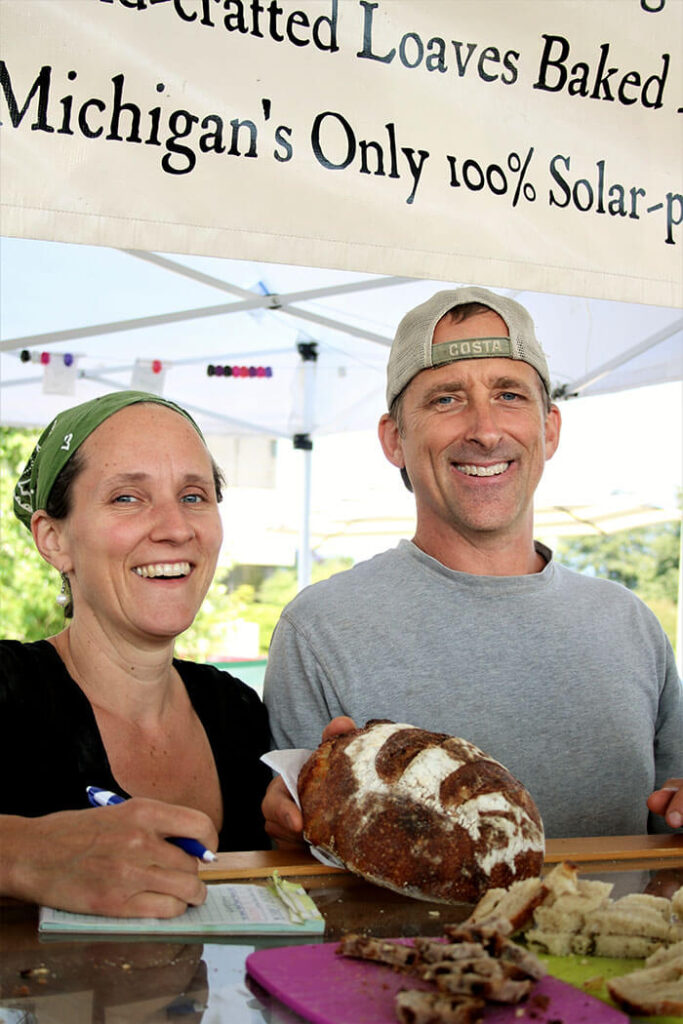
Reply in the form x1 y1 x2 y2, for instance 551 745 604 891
0 391 270 916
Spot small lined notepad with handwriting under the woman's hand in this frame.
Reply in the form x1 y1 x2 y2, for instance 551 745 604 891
39 882 325 935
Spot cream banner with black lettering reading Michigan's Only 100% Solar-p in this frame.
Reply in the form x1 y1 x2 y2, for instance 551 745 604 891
0 0 683 306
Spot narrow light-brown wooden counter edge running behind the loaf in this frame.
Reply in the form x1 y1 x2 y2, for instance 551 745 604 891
200 834 683 882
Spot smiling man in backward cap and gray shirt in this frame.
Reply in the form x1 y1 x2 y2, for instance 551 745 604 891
264 288 683 837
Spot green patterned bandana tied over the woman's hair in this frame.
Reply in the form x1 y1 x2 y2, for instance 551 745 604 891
14 391 204 529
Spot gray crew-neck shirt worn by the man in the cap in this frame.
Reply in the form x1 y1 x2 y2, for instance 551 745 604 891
264 541 683 837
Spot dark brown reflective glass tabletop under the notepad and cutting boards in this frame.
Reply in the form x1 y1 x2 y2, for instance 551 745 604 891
0 836 683 1024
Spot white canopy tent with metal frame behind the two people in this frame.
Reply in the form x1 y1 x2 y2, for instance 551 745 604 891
0 239 683 584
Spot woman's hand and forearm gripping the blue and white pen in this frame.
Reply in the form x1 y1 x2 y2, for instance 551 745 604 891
1 797 218 918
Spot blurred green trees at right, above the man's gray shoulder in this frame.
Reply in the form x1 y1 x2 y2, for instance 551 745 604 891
556 522 681 645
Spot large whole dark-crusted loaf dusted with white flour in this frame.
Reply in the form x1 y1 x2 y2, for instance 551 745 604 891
298 721 545 903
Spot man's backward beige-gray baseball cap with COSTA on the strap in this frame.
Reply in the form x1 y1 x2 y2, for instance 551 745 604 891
387 287 550 409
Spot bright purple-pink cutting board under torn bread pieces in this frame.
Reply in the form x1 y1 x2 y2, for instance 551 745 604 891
247 942 629 1024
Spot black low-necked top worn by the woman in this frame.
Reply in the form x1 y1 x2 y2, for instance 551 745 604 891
0 640 271 850
